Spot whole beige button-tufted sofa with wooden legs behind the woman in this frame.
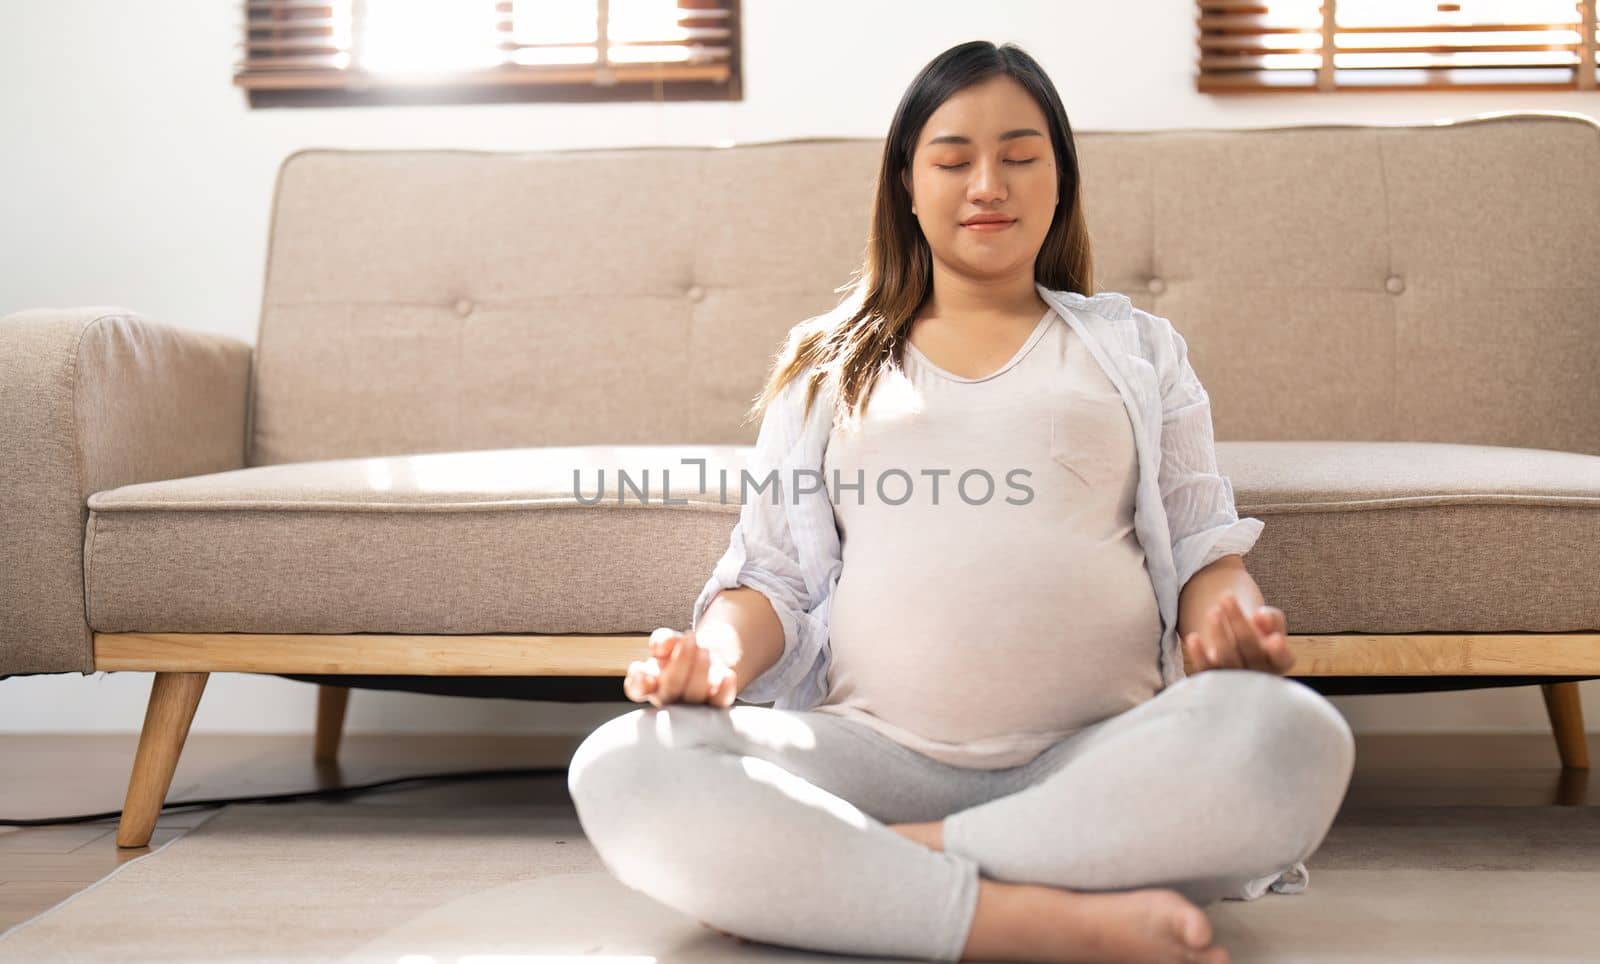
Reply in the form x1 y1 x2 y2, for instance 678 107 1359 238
0 115 1600 846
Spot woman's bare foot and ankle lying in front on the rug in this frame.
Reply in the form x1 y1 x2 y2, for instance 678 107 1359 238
962 878 1229 964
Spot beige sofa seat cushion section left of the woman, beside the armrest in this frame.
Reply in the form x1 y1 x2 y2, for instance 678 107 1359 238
85 445 752 634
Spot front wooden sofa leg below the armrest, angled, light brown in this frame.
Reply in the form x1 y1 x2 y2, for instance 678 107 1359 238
117 673 211 847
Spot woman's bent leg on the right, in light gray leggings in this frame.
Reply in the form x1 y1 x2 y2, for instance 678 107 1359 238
939 669 1355 905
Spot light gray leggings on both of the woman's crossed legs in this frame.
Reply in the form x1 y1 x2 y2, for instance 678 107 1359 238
568 669 1355 961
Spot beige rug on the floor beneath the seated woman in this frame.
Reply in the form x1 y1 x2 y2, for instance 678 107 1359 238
0 802 1600 964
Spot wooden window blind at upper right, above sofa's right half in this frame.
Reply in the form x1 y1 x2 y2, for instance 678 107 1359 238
1198 0 1597 93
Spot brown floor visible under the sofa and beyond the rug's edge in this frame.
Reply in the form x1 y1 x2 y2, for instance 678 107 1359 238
0 727 1600 930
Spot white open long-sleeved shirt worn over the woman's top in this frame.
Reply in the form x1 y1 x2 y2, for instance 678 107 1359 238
690 285 1309 900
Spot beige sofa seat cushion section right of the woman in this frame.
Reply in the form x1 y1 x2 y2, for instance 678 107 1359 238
1216 442 1600 634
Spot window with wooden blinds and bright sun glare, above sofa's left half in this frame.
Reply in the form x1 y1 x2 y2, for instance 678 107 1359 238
234 0 741 107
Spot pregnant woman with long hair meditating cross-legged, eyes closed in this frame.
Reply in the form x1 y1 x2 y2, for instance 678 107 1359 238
568 42 1355 964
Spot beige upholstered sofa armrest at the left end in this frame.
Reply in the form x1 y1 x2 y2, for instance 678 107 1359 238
0 307 251 679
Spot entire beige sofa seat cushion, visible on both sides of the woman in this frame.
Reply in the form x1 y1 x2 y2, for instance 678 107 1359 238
85 442 1600 634
